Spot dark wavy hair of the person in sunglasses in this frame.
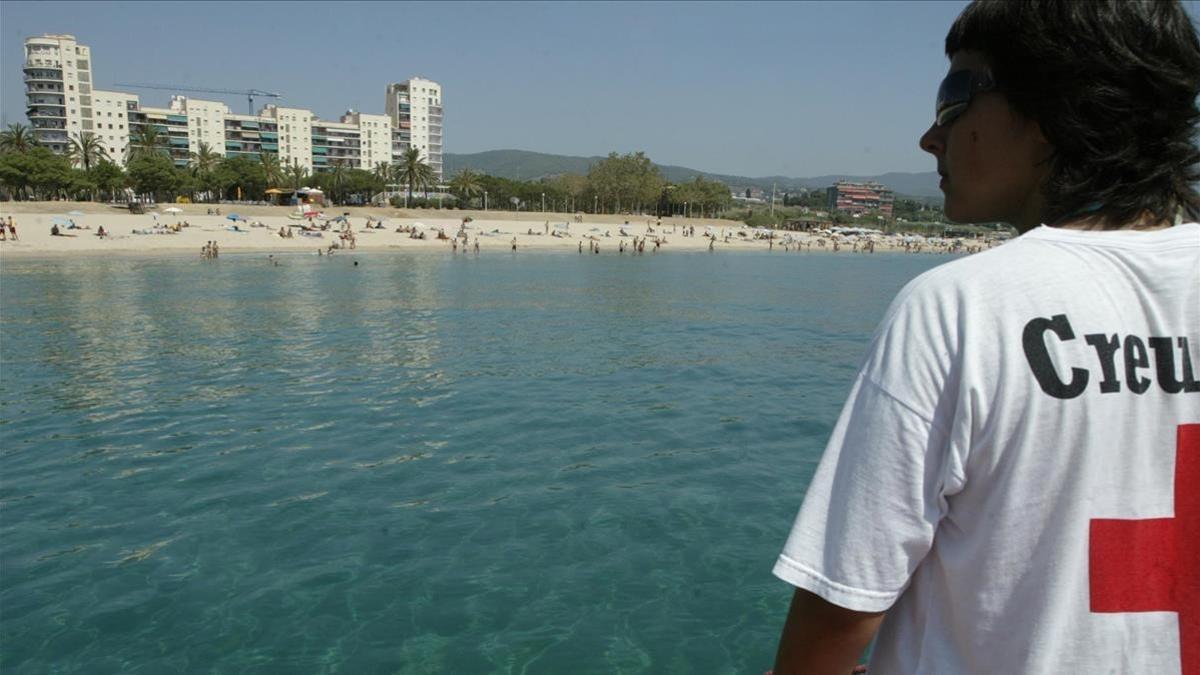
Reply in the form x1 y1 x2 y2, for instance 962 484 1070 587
946 0 1200 228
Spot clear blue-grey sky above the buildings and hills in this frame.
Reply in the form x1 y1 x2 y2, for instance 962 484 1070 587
0 0 1198 177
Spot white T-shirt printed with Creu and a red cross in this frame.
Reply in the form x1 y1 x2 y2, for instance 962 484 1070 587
774 223 1200 675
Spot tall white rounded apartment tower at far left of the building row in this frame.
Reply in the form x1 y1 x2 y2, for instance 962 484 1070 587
24 35 92 153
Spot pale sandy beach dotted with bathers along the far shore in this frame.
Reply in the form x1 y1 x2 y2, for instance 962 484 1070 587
0 202 936 257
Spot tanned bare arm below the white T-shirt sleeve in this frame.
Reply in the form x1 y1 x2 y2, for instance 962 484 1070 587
774 589 883 675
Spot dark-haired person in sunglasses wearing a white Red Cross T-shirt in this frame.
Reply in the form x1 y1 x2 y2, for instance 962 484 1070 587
774 0 1200 675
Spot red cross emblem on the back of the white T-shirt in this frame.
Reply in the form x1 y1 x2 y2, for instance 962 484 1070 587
1088 424 1200 675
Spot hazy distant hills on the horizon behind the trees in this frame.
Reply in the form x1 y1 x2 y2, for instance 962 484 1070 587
443 150 942 201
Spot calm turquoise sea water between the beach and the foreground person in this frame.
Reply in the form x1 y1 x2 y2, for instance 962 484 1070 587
0 252 946 674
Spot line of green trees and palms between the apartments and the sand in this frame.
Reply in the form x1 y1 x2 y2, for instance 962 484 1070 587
0 124 731 216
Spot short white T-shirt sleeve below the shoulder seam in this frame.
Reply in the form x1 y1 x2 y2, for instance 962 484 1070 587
774 376 946 611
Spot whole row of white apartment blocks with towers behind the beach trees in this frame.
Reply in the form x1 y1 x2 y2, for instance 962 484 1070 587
24 35 442 180
